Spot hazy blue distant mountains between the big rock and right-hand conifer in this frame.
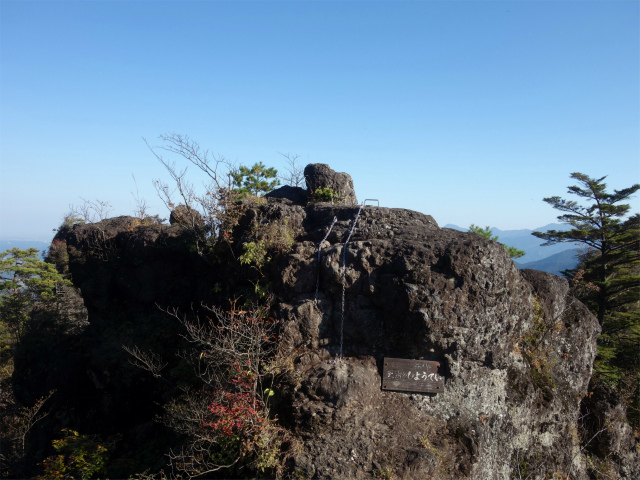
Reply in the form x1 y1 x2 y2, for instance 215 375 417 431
444 223 582 275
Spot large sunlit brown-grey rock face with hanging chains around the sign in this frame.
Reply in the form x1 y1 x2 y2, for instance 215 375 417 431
258 204 599 479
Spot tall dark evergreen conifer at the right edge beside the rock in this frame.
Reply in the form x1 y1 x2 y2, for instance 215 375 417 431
533 173 640 426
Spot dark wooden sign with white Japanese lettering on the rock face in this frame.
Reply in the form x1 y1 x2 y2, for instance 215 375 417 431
382 358 444 393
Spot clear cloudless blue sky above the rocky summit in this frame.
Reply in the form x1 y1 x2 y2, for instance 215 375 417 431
0 0 640 240
